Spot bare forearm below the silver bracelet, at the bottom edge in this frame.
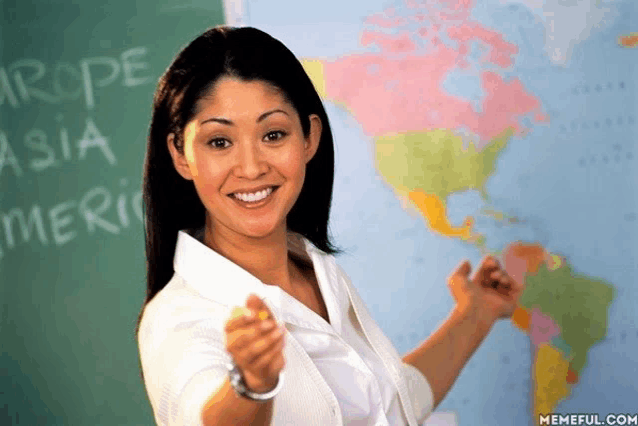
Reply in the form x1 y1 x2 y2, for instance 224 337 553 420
202 379 276 426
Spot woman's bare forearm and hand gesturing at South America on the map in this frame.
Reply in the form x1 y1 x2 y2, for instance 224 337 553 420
403 256 523 408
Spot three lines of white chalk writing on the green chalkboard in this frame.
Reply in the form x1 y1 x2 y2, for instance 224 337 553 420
0 46 153 266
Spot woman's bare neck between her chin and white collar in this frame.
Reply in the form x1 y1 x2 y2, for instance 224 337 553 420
204 221 299 292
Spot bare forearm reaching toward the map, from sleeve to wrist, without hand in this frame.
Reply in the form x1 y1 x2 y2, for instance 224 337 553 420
403 309 491 408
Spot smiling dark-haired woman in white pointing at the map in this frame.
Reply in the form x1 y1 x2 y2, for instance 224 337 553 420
138 27 520 426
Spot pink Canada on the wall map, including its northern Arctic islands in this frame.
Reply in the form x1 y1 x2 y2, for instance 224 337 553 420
324 0 546 149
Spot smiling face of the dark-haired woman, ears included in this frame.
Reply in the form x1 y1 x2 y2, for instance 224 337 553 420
168 77 321 243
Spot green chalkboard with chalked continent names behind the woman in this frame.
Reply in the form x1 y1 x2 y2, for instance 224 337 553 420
0 0 224 426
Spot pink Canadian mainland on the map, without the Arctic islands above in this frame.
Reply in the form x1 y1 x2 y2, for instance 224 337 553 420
324 48 540 143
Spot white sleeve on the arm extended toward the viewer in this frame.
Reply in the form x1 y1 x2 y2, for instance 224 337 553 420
138 296 231 426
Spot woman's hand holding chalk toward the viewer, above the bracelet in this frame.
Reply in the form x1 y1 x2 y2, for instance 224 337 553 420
224 294 285 393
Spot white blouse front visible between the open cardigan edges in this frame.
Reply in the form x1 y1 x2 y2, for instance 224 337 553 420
271 250 407 426
